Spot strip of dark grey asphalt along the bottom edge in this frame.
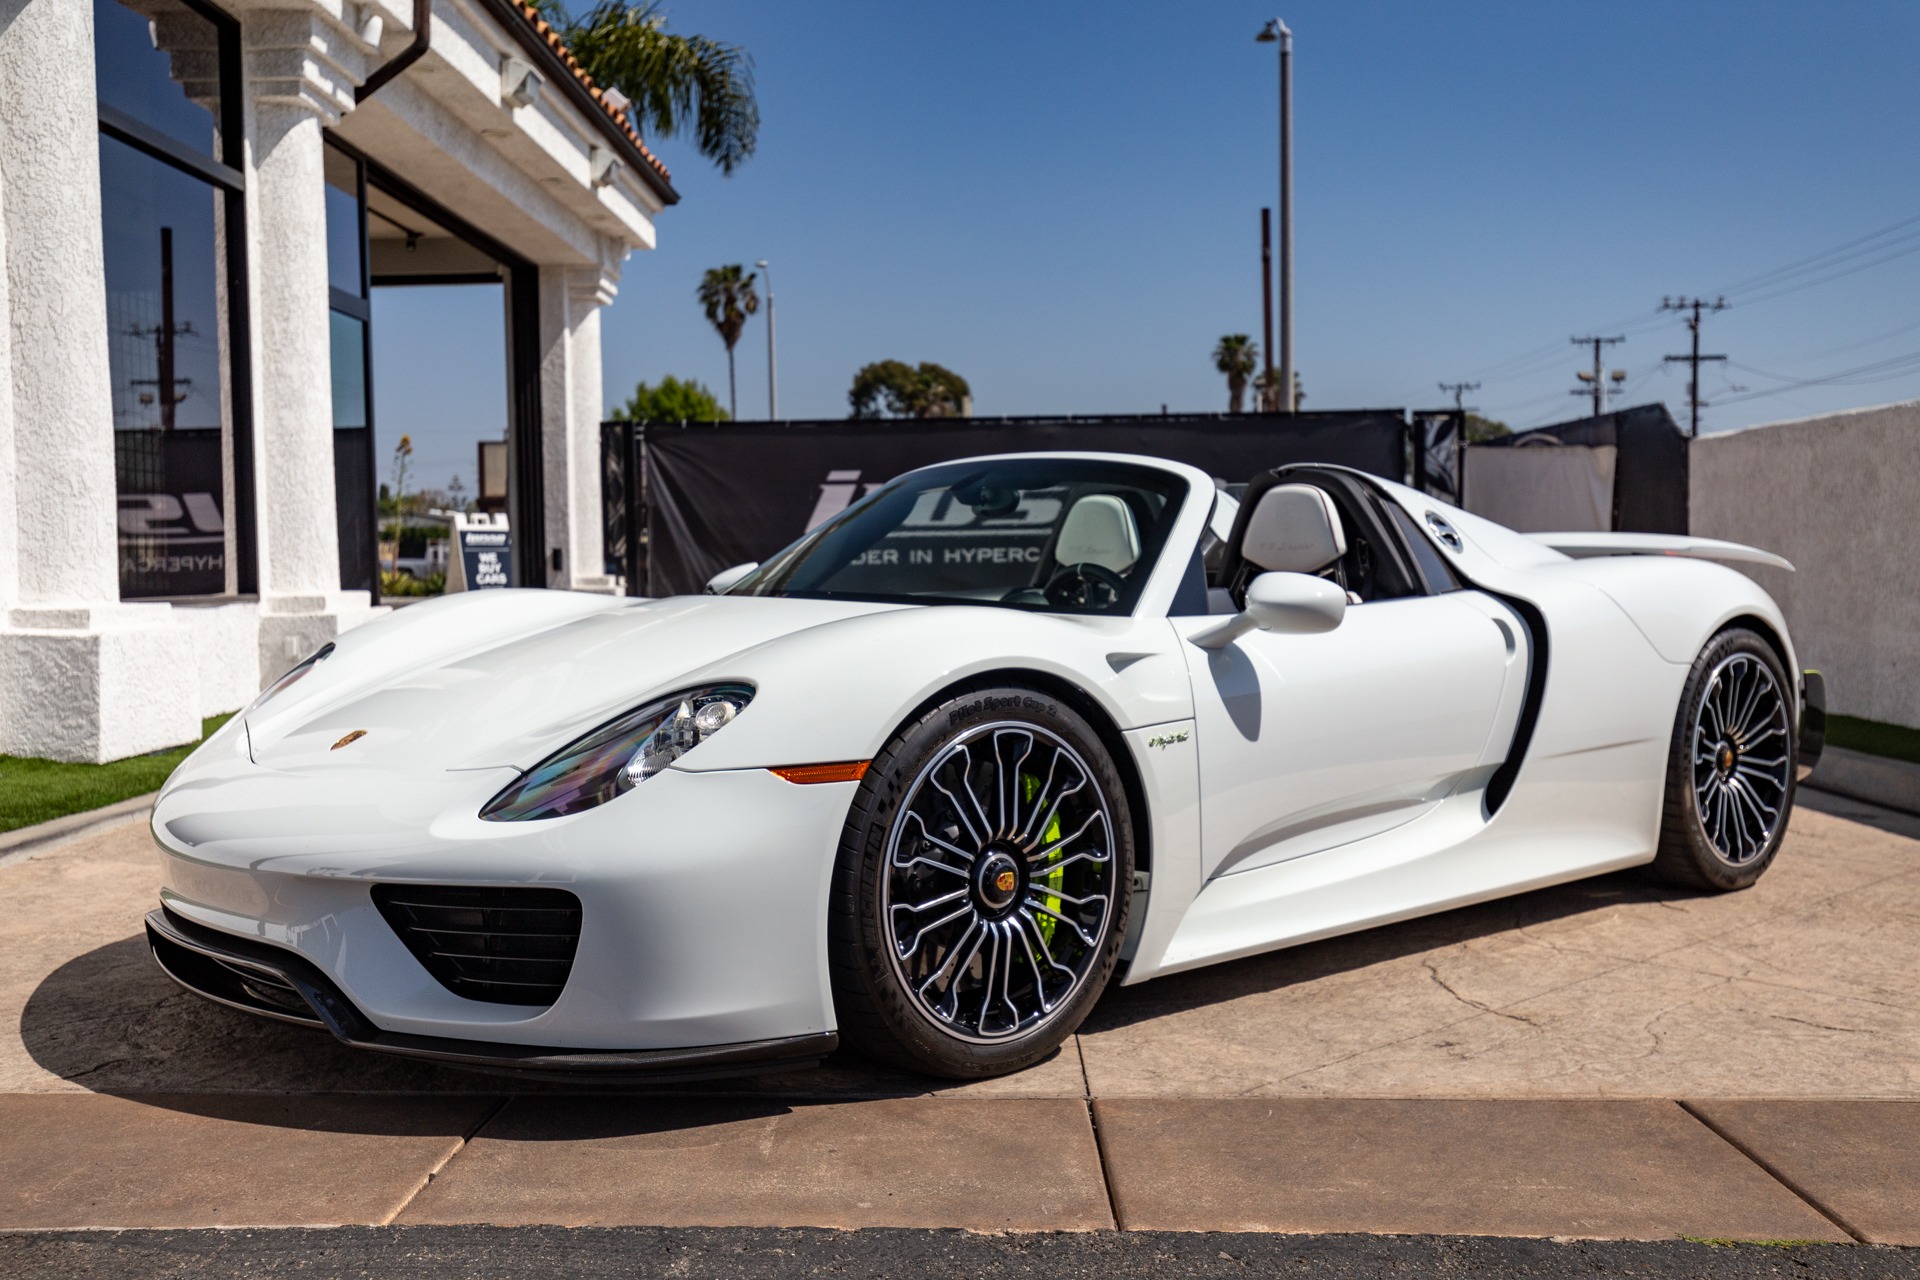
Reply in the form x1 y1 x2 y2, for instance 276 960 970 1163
0 1226 1920 1280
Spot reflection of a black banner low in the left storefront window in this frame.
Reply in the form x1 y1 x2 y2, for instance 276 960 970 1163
113 428 227 601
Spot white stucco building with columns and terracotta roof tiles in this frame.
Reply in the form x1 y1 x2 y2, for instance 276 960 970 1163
0 0 676 760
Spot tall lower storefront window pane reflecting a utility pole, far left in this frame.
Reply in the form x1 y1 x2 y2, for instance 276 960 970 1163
100 134 230 599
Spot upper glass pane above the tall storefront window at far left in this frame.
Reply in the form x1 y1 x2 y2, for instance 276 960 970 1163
94 0 232 163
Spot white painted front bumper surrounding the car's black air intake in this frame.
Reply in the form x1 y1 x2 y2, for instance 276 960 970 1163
154 760 854 1055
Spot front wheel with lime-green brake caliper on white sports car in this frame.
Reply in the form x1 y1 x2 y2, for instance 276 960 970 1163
828 685 1133 1079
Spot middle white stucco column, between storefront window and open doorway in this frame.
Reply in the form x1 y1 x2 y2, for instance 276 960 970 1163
242 10 372 681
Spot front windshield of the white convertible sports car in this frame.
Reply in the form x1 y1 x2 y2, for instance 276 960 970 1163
728 459 1187 614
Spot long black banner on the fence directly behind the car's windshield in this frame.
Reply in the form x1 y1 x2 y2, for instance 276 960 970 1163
633 411 1409 595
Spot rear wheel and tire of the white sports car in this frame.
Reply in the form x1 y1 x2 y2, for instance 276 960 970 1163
1653 628 1799 892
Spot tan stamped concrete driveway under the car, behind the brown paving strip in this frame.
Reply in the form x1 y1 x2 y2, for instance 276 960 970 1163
0 793 1920 1098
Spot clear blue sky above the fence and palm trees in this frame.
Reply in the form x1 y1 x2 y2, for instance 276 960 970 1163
370 0 1920 479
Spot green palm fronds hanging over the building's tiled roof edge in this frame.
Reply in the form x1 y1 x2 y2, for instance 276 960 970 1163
530 0 760 173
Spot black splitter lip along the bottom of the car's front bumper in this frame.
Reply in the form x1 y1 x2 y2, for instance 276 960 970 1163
146 908 839 1082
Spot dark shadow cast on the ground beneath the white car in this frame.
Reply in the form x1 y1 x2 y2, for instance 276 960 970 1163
19 873 1690 1134
